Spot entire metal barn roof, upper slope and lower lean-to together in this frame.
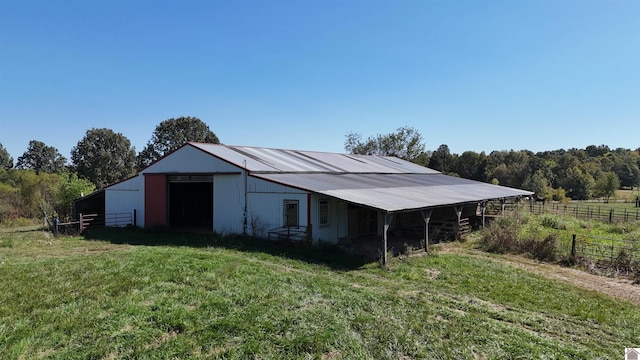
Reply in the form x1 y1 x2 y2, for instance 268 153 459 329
189 143 533 212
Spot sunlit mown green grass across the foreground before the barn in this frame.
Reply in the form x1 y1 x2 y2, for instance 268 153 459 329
0 230 640 359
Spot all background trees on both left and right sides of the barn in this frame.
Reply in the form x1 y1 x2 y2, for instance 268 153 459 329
0 121 640 223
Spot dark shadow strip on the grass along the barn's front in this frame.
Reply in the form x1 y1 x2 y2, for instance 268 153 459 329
84 228 374 271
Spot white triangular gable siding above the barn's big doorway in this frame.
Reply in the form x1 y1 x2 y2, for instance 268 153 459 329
142 145 240 173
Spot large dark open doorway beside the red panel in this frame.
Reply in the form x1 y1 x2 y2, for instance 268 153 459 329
169 181 213 231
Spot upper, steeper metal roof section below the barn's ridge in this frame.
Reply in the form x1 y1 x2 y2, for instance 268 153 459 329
189 143 439 174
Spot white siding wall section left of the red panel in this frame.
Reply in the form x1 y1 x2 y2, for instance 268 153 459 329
104 175 144 227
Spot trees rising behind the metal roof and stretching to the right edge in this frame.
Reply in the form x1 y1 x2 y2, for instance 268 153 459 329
345 127 640 201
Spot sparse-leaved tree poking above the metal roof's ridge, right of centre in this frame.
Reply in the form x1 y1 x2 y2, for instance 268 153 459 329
344 126 425 161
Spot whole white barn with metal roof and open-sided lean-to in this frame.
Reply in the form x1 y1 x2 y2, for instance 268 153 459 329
76 143 532 262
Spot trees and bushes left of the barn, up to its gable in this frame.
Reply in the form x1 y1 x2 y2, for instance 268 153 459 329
0 117 219 224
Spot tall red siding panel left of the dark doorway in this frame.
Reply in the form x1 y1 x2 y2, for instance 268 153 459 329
144 174 167 227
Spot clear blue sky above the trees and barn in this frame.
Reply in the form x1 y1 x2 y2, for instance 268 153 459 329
0 0 640 160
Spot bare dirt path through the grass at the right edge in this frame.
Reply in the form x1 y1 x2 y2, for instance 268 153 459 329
438 244 640 304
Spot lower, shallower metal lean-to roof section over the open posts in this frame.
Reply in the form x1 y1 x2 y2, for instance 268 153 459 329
252 173 533 212
